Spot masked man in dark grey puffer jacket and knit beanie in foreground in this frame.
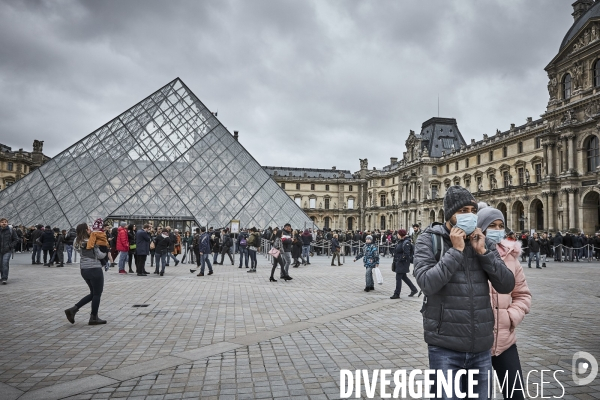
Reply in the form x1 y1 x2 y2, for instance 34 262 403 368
413 186 515 399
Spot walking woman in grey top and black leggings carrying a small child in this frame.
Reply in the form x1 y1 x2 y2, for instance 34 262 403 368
65 224 106 325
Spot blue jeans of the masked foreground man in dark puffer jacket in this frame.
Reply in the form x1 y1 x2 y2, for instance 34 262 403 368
425 345 492 400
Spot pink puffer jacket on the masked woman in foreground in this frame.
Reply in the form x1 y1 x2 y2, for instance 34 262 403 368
490 239 531 356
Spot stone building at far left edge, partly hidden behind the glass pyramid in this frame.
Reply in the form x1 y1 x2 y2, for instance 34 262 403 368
0 140 50 190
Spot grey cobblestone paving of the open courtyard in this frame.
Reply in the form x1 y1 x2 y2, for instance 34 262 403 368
0 254 600 400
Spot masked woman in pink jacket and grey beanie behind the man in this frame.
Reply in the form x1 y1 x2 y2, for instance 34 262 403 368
477 203 531 399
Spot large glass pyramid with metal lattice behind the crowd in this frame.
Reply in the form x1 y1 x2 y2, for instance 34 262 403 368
0 78 313 229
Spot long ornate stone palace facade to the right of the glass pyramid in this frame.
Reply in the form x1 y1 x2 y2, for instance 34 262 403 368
263 0 600 233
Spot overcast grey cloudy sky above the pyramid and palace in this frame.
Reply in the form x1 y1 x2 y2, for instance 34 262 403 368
0 0 573 171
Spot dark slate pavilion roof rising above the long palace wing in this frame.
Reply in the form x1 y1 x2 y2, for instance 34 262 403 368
421 117 467 158
